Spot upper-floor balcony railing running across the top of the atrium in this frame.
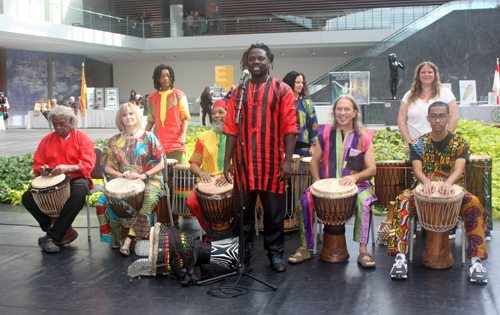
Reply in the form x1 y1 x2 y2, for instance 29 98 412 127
3 0 450 38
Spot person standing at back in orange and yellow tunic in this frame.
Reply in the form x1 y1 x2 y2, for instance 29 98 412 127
146 64 191 164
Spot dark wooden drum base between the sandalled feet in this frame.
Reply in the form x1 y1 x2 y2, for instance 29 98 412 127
319 225 349 263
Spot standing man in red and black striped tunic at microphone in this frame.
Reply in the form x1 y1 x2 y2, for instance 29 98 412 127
224 43 299 272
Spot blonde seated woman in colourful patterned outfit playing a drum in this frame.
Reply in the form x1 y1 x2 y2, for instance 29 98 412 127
97 103 164 256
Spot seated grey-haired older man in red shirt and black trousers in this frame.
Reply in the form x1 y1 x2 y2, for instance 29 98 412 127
23 106 96 253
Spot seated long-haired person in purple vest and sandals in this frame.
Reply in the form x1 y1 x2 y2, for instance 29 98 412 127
288 94 377 268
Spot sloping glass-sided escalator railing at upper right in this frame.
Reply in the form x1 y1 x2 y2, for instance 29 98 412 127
308 0 500 100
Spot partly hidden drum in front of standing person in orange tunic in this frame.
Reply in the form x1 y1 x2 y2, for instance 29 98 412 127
172 164 197 216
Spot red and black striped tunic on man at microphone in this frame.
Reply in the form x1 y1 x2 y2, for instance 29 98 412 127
224 77 300 193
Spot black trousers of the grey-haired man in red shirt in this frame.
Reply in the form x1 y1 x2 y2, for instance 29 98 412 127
23 177 90 242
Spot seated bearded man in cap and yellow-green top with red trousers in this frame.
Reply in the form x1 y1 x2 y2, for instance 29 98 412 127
187 99 228 239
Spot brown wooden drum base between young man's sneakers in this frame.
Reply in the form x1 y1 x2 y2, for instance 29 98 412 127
422 231 455 269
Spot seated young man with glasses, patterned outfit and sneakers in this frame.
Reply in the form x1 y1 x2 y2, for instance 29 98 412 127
388 102 488 283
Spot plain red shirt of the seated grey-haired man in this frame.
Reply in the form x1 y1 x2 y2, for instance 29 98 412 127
33 129 95 182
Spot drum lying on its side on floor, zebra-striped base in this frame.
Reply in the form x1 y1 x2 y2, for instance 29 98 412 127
128 223 238 278
